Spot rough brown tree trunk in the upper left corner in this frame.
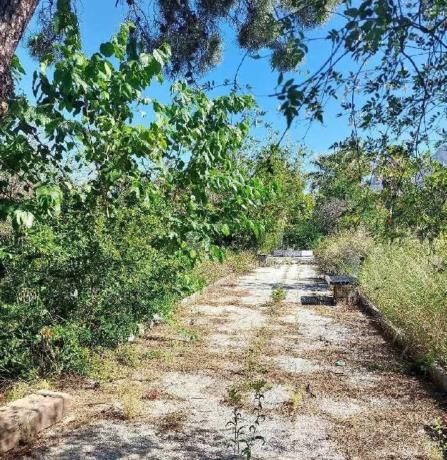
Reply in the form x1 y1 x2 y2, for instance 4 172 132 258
0 0 39 118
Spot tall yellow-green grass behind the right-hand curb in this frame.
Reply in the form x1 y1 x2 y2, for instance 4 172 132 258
360 237 447 364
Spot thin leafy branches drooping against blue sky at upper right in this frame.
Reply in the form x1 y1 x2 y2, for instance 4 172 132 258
277 0 447 152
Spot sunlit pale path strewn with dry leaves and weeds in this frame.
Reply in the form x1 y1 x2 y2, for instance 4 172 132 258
22 265 442 460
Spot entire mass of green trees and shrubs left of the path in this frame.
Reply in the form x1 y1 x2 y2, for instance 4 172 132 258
0 23 312 378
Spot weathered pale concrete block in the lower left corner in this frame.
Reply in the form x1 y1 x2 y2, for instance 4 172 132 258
0 390 71 453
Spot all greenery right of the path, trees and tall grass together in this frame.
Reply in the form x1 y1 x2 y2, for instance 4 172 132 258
313 146 447 365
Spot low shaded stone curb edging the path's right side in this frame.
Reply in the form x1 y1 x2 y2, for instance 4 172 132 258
357 293 447 393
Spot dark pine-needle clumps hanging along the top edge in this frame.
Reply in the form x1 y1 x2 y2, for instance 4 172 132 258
30 0 337 74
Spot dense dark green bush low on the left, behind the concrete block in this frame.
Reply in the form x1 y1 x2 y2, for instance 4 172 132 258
0 203 186 378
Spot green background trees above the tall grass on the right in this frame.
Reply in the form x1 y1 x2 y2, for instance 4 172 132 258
311 144 447 239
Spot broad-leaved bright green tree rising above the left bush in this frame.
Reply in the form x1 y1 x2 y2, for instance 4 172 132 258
0 23 269 258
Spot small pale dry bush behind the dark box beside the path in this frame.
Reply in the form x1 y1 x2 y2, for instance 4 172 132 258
315 227 374 276
